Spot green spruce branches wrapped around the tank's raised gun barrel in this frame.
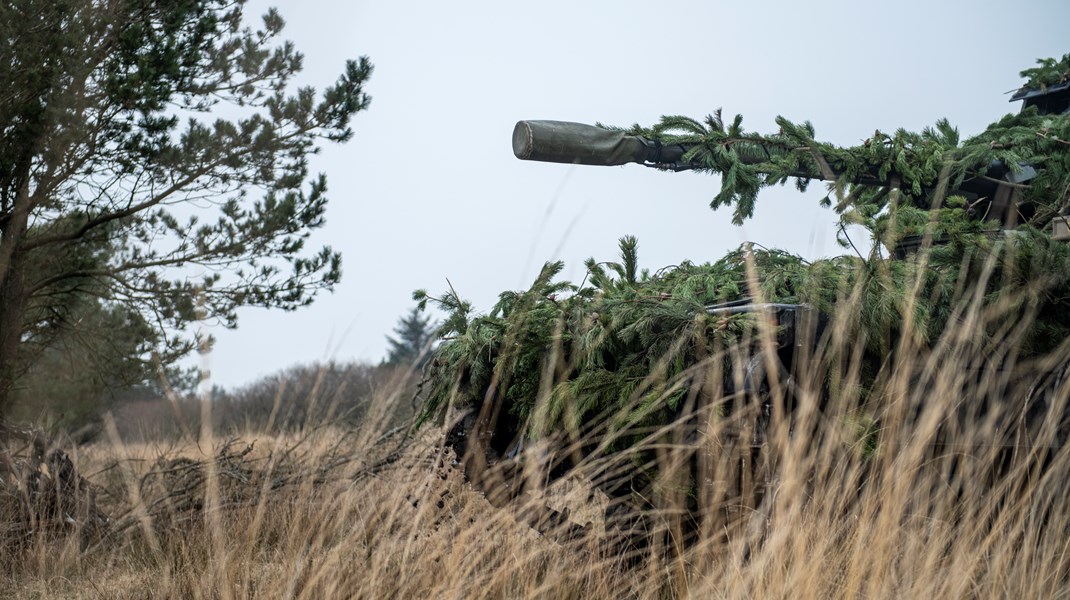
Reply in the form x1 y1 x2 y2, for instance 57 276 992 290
629 75 1070 228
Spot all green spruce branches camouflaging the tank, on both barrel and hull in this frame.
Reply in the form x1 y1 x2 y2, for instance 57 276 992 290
417 52 1070 453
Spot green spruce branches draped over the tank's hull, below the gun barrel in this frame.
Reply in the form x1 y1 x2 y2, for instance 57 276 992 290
422 226 1070 437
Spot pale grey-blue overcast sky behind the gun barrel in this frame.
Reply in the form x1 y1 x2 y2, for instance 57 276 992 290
203 0 1070 388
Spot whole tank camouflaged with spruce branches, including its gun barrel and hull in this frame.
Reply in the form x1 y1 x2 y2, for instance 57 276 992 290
422 55 1070 551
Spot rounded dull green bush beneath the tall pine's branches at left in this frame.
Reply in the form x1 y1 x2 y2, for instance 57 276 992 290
11 212 195 429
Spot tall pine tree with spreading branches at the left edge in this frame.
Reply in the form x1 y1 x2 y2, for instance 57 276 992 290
0 0 371 418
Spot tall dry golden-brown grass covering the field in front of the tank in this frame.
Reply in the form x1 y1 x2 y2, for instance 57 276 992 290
0 254 1070 599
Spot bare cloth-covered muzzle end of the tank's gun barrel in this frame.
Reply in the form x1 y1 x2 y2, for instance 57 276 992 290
513 121 656 167
